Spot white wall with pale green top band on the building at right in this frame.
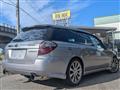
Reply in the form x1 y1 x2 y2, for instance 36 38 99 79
94 15 120 40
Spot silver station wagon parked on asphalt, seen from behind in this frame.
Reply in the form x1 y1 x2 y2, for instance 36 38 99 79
2 25 119 85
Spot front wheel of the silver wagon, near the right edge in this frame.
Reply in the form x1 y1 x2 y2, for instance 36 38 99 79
109 58 119 73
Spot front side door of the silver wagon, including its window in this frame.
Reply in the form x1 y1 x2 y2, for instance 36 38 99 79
90 35 111 69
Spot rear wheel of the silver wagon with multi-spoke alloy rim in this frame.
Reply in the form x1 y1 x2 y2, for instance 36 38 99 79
66 58 83 86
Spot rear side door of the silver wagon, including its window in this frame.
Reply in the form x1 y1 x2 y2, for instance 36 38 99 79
76 33 99 71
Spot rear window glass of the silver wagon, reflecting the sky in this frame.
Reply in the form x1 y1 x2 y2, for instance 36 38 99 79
12 29 49 42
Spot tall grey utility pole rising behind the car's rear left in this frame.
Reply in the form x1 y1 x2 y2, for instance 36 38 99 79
16 0 20 34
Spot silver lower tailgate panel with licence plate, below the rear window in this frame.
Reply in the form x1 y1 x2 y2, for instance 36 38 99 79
6 41 42 64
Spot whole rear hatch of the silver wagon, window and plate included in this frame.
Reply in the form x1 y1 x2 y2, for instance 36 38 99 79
5 29 52 64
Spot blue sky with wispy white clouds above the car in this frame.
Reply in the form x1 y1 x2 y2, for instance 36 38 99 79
0 0 120 27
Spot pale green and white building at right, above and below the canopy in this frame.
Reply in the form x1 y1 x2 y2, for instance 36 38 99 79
94 15 120 56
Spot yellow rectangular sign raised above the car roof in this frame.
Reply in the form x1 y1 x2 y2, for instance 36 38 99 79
52 10 70 20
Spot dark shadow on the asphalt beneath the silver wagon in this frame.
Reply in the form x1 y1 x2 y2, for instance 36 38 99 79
26 71 120 90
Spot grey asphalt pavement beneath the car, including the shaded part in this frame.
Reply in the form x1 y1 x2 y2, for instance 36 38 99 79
0 62 120 90
